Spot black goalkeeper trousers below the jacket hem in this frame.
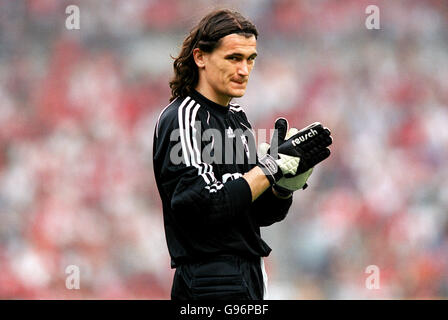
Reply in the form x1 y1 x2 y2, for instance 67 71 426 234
171 255 264 300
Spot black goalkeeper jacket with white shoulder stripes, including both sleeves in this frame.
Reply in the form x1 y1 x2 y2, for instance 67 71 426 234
153 91 292 268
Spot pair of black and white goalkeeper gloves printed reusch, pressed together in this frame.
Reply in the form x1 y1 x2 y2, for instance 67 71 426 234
259 118 332 186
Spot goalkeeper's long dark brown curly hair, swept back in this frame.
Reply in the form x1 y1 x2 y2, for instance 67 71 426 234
170 9 258 101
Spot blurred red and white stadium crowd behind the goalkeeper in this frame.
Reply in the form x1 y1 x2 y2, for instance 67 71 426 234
0 0 448 299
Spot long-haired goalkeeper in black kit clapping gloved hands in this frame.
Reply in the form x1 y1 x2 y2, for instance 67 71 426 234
153 10 332 300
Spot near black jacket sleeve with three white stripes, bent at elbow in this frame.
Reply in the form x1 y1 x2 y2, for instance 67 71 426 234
154 105 252 227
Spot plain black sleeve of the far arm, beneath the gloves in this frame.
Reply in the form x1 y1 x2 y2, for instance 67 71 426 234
251 187 293 227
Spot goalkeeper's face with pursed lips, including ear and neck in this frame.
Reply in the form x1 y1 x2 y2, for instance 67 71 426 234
199 33 257 101
